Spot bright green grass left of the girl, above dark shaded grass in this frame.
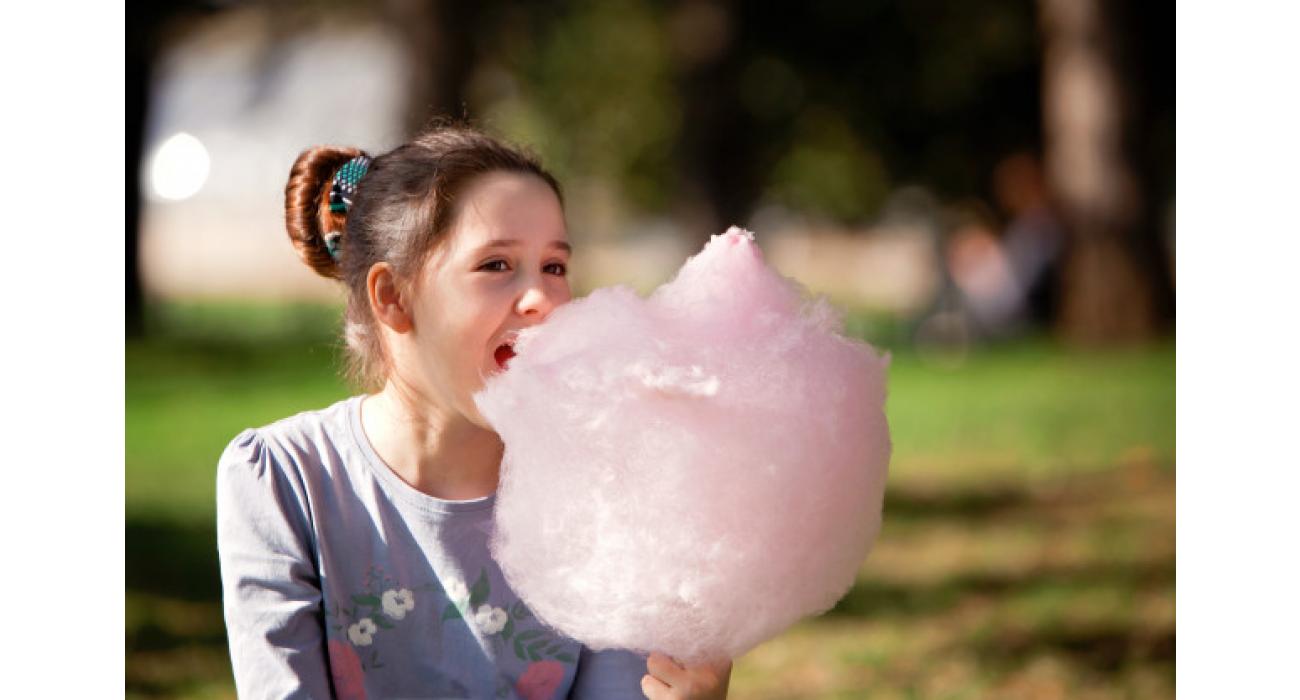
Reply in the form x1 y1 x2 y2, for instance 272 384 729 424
126 299 348 519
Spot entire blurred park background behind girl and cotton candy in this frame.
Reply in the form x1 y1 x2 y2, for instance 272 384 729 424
126 0 1175 699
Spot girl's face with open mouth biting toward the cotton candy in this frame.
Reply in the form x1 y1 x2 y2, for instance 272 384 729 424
411 172 572 428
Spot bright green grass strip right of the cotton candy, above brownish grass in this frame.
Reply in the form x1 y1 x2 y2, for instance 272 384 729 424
887 340 1174 485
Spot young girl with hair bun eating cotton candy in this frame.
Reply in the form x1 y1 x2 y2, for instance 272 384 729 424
217 126 731 700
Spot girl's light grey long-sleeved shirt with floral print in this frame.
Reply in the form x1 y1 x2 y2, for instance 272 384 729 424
217 397 646 700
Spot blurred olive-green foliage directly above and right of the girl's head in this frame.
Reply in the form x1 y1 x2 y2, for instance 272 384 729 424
472 0 683 236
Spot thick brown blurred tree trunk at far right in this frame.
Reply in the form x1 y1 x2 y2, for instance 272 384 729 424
1039 0 1157 343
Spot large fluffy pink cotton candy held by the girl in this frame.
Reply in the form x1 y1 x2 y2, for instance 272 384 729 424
475 228 891 664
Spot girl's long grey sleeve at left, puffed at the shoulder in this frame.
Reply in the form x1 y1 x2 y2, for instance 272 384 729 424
217 429 332 697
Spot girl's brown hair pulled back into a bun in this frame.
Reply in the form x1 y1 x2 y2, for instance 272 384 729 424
285 124 564 390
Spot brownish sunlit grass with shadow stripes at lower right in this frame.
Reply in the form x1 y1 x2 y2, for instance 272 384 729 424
732 466 1175 699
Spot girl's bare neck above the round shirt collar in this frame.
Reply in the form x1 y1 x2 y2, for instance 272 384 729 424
361 381 504 501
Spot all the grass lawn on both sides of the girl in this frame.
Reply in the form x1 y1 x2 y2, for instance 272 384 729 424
126 296 1175 697
